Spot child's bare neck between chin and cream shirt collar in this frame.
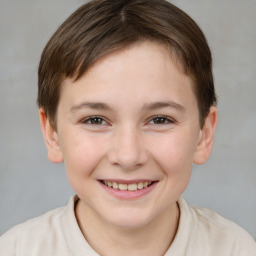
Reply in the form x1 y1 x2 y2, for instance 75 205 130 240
76 200 179 256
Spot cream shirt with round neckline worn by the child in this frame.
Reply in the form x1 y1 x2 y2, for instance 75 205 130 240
0 196 256 256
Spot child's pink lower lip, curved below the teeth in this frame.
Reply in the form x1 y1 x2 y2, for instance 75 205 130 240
99 181 157 200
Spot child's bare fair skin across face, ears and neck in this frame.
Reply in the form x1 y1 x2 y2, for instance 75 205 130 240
40 41 217 256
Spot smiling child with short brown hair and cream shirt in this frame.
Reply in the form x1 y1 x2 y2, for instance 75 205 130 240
0 0 256 256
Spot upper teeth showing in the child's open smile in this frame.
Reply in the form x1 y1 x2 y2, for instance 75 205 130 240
100 180 157 191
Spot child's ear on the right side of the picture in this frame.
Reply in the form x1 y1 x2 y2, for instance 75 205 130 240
193 106 218 164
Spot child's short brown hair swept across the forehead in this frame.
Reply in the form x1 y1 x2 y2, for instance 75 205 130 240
37 0 216 129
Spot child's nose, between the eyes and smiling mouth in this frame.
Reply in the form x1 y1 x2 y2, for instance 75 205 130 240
108 128 149 171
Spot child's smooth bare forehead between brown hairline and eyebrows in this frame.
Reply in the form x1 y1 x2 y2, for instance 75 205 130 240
60 41 195 113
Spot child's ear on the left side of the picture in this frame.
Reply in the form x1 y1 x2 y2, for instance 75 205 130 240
39 108 63 163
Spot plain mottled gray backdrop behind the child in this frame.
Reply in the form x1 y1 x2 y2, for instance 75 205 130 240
0 0 256 238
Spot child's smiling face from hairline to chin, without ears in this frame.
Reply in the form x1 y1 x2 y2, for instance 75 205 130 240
42 42 216 227
